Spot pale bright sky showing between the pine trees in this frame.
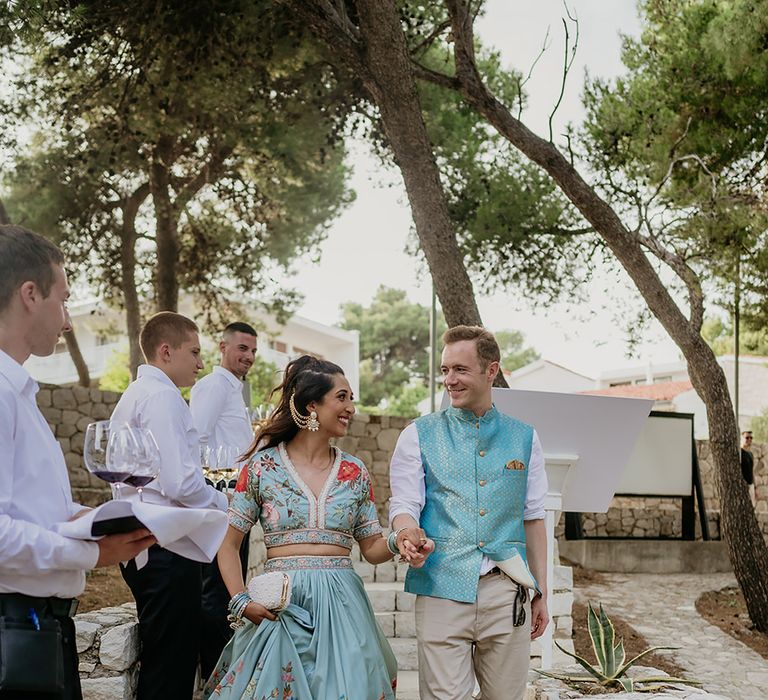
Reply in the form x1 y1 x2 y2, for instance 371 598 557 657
286 0 680 376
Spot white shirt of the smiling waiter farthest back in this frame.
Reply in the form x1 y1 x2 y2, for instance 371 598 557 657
189 367 253 454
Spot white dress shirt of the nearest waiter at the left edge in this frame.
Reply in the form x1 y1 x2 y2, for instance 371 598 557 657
0 350 99 598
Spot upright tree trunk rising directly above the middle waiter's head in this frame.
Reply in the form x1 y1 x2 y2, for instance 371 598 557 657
150 137 179 311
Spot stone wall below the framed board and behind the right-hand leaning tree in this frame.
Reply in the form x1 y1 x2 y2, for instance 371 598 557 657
556 440 768 539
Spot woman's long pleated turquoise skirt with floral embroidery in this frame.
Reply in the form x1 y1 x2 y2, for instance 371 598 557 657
204 556 397 700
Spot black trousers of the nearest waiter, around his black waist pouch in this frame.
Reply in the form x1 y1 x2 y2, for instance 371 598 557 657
0 593 83 700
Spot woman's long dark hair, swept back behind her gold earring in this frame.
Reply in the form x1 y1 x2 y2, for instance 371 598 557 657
243 355 344 459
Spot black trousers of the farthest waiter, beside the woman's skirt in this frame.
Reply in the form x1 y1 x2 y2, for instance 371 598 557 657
200 535 249 681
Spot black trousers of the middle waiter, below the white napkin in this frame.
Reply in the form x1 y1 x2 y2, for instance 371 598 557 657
120 545 202 700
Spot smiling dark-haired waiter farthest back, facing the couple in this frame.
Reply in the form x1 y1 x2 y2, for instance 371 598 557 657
189 322 257 678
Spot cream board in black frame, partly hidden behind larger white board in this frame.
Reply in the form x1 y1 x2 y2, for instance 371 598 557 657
616 413 693 496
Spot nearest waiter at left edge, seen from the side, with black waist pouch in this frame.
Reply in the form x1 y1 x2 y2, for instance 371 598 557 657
0 226 155 700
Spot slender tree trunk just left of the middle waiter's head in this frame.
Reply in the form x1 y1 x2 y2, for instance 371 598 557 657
120 185 150 379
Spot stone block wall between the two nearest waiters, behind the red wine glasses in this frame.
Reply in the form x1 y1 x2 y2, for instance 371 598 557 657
37 384 120 506
